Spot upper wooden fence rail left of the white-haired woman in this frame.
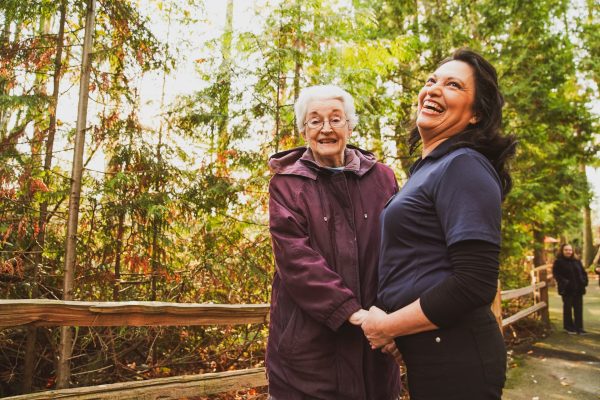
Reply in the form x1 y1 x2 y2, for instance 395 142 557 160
0 299 269 327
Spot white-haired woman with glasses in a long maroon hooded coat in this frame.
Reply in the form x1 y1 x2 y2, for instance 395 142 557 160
266 86 400 400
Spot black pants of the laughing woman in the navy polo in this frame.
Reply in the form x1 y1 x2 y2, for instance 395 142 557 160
396 307 506 400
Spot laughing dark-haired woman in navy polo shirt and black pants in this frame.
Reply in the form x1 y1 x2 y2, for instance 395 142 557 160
362 50 515 400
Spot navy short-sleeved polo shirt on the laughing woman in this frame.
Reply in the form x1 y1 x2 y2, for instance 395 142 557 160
378 137 502 312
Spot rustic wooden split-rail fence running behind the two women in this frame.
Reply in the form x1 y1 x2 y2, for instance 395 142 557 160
0 265 550 400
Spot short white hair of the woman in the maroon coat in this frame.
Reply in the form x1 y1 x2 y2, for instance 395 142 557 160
294 85 358 132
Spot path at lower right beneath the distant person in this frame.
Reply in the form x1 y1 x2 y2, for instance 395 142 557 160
502 276 600 400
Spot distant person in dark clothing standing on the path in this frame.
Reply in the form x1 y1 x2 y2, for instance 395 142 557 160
552 243 588 335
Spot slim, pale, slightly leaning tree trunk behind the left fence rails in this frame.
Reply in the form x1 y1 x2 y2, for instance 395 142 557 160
56 0 96 389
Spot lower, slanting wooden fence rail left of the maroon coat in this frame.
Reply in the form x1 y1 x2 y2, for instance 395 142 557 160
5 368 267 400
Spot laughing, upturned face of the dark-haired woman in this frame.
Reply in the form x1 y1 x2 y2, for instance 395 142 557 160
417 60 477 146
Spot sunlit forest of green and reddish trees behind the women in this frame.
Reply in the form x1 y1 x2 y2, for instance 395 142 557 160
0 0 600 395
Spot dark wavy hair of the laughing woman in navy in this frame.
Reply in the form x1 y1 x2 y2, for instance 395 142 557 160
408 49 517 198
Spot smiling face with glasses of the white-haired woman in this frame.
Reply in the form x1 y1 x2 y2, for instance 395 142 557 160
304 99 352 167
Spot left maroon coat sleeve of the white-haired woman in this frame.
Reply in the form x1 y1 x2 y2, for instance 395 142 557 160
269 176 361 330
